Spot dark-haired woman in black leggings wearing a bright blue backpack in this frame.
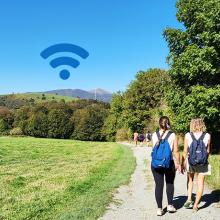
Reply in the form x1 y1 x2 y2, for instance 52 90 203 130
151 116 181 216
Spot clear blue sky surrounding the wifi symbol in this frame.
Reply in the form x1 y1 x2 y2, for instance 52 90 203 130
0 0 180 94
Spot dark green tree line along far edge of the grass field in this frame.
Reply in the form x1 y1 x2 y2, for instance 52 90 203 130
0 96 109 141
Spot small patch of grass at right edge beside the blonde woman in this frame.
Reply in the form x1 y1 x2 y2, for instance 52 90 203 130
206 155 220 190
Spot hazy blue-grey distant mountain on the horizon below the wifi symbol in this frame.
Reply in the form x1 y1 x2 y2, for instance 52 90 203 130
44 88 112 102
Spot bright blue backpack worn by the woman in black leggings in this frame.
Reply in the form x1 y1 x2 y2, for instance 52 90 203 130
151 131 172 168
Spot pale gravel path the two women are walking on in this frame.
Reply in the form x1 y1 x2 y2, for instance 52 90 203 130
99 145 220 220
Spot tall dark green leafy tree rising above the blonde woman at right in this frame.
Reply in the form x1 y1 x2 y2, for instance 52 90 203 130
164 0 220 148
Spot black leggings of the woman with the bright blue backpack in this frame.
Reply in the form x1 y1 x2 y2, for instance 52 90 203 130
151 161 176 208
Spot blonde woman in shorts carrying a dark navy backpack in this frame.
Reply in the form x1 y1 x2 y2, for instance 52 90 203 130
183 118 211 211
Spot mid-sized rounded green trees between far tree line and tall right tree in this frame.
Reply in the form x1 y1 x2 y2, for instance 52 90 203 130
103 68 170 141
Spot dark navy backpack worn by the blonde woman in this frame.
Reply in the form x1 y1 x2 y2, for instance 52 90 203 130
189 132 208 166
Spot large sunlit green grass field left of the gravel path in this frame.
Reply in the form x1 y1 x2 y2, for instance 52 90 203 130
0 137 135 220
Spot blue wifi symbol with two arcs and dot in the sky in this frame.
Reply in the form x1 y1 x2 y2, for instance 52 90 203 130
40 43 89 80
